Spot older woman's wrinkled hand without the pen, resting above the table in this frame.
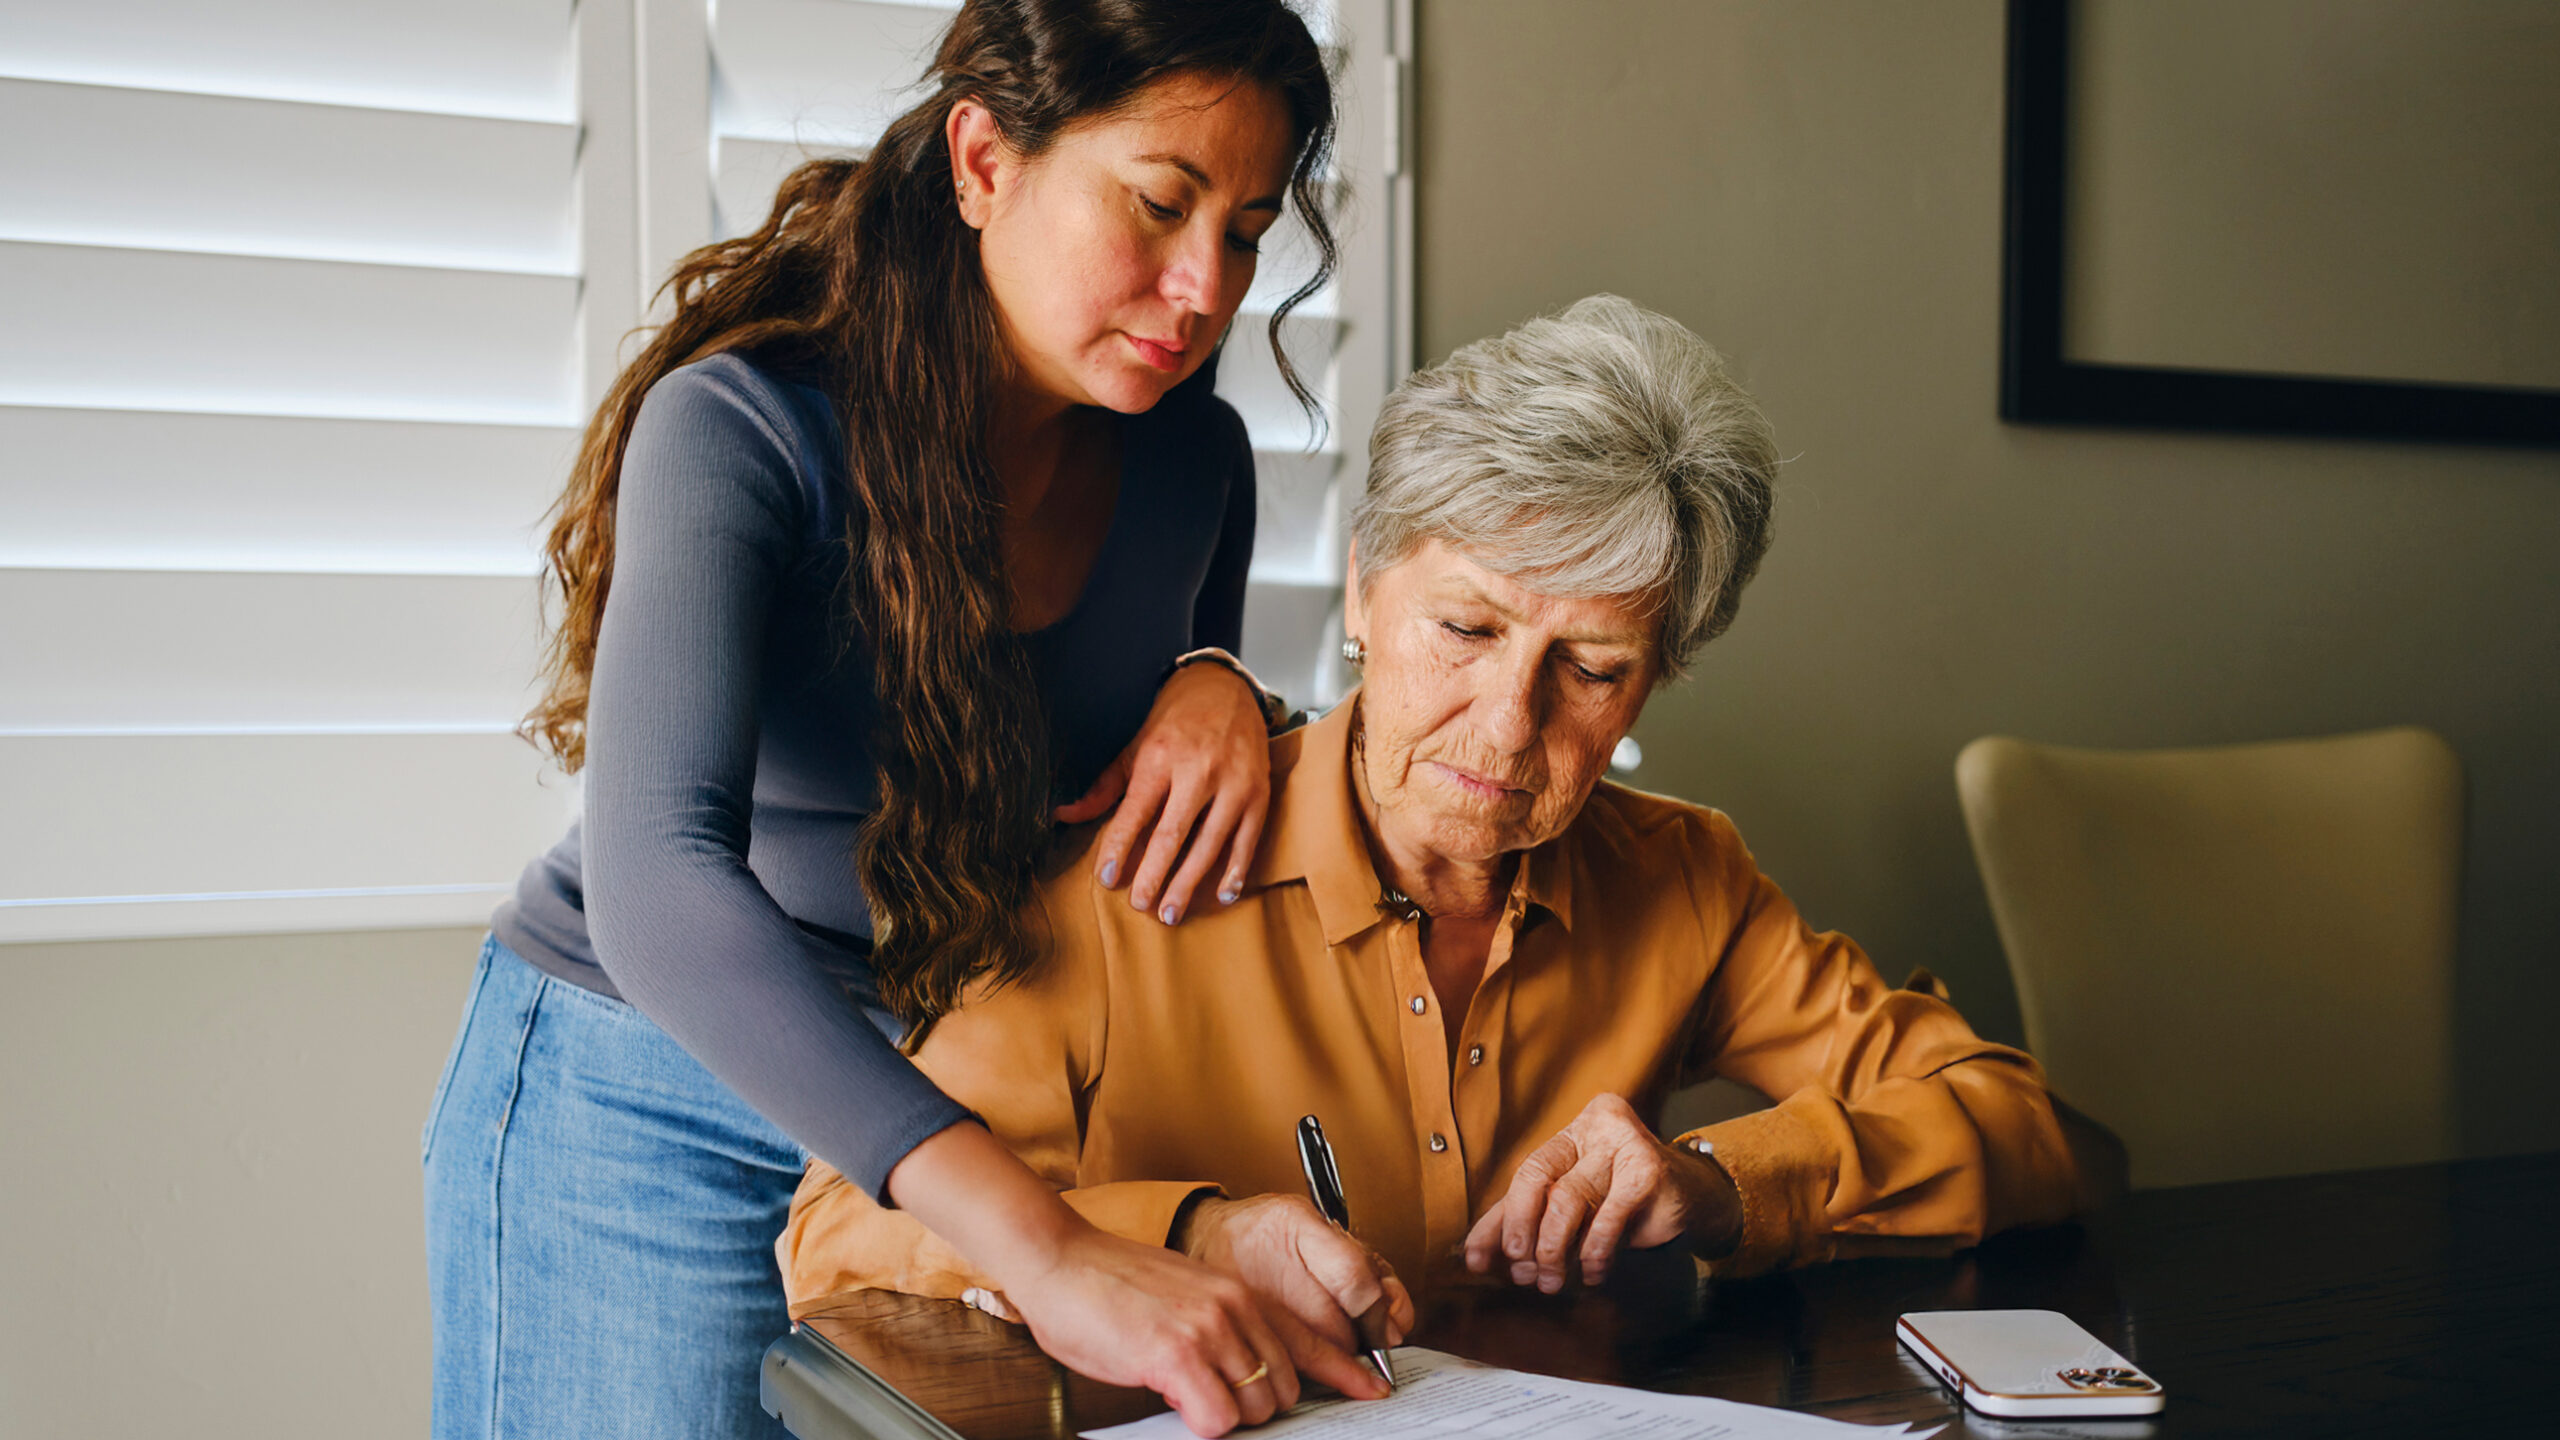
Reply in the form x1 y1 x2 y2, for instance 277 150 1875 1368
1467 1094 1741 1294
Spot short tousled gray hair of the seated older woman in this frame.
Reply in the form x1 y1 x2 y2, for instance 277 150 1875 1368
1352 295 1777 674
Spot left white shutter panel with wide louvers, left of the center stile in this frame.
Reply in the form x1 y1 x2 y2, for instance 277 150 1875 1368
0 0 588 940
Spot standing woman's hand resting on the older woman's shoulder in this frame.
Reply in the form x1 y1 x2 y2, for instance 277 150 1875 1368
1057 664 1272 925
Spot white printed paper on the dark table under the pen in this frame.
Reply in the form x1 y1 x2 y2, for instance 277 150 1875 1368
1085 1345 1912 1440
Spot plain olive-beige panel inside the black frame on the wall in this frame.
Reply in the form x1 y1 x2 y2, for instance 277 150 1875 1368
2063 0 2560 387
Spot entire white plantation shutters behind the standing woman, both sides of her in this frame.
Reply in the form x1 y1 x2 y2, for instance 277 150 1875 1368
0 0 1411 940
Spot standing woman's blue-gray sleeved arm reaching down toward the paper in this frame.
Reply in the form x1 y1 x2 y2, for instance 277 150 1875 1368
584 361 968 1194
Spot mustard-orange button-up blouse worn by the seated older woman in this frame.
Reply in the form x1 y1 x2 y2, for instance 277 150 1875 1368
778 705 2074 1312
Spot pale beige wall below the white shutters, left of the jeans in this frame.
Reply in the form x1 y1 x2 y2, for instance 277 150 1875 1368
0 930 479 1440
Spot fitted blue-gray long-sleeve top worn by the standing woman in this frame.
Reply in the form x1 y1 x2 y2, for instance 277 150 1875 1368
492 356 1254 1197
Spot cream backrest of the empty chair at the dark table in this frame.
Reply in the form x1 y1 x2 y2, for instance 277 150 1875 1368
1956 728 2463 1189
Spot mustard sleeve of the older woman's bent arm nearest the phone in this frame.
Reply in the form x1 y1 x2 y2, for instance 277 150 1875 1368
1687 815 2074 1276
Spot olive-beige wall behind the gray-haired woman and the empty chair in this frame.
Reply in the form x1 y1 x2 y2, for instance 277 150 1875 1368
1416 0 2560 1150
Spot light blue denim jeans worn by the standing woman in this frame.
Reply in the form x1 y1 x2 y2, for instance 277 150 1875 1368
420 938 804 1440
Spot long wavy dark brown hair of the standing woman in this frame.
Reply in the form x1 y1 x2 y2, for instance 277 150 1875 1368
522 0 1336 1022
